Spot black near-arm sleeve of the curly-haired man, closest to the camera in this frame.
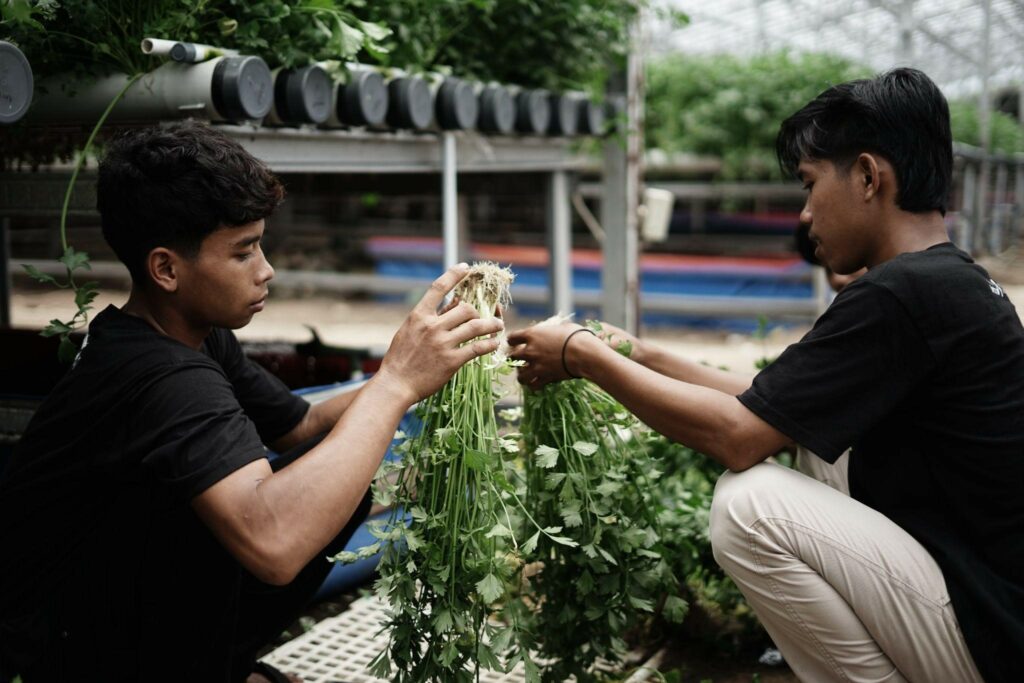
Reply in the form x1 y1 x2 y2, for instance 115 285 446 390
136 364 266 500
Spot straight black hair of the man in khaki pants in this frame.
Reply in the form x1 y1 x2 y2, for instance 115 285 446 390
775 69 953 215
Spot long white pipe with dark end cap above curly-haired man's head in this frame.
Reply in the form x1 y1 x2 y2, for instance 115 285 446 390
29 56 273 124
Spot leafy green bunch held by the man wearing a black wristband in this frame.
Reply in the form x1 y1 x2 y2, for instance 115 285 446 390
521 324 687 682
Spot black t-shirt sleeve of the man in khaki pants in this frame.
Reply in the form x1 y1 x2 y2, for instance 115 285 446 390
738 281 934 463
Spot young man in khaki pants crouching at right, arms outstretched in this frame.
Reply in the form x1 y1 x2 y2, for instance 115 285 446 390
509 69 1024 683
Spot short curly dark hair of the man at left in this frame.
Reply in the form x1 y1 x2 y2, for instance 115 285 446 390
96 122 285 284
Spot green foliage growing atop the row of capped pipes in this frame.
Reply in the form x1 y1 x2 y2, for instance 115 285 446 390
0 0 638 89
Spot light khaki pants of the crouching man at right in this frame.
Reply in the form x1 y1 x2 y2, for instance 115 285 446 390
711 452 982 683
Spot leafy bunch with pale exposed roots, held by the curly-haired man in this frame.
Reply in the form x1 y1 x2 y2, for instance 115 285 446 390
336 264 572 681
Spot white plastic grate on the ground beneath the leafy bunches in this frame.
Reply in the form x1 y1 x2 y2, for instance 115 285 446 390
263 596 651 683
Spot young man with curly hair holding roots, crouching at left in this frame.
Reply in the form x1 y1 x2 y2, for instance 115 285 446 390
0 124 501 683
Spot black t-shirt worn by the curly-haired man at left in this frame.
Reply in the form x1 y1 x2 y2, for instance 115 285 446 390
0 306 308 681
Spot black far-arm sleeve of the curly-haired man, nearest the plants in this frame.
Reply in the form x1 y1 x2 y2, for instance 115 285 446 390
207 330 309 443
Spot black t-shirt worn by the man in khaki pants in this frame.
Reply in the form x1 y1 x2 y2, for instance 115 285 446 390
739 243 1024 681
